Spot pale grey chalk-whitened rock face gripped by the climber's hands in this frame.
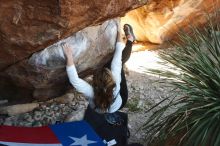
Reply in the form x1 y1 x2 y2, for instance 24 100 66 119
28 19 119 71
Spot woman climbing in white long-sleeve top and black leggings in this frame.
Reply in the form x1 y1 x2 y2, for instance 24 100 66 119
61 24 135 125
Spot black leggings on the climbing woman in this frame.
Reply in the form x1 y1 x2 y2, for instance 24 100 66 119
104 40 132 109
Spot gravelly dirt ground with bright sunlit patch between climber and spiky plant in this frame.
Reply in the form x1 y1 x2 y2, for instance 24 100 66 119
123 51 173 145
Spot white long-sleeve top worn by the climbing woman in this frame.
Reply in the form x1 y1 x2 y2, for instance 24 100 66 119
66 42 125 113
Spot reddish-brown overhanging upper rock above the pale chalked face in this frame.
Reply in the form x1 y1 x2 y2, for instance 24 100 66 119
0 0 147 71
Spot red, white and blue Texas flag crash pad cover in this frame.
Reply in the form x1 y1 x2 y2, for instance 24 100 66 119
0 121 105 146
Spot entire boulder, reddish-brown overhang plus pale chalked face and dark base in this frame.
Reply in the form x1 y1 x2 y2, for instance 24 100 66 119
0 0 147 101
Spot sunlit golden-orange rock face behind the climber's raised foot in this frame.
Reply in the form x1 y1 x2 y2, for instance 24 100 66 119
122 0 220 44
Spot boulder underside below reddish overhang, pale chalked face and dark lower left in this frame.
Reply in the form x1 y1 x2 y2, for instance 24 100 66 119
0 20 118 99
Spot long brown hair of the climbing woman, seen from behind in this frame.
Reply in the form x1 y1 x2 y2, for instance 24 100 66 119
93 68 116 111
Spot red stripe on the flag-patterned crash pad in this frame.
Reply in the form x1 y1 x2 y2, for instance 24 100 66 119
0 126 60 144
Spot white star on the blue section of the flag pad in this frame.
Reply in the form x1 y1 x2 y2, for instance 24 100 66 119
69 135 97 146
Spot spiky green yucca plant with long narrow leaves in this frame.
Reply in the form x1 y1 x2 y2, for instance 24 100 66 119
143 12 220 146
